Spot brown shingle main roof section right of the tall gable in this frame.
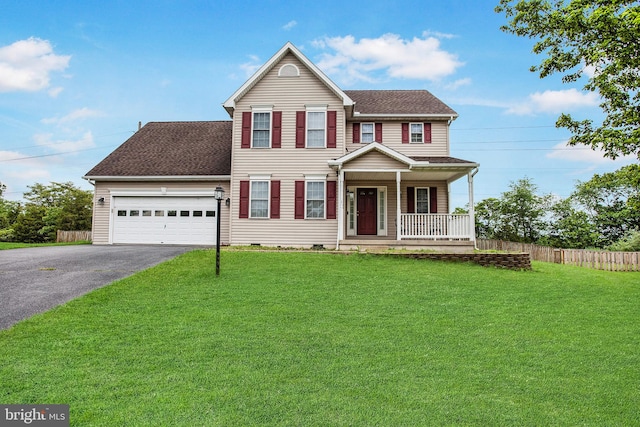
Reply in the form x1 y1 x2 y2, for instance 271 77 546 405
344 90 458 116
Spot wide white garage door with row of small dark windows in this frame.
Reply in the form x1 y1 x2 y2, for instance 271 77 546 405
112 196 217 245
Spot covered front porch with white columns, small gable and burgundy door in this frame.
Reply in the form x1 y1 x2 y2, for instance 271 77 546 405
329 142 478 252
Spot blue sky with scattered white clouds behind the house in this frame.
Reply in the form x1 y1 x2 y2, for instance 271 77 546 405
0 0 634 207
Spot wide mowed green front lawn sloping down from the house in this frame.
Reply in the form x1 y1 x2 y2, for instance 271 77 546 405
0 251 640 426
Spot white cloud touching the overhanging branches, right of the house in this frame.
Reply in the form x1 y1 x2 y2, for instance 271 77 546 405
507 89 598 115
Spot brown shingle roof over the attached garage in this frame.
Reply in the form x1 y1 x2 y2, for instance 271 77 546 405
86 121 232 178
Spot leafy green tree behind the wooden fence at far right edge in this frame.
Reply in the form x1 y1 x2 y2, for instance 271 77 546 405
571 164 640 247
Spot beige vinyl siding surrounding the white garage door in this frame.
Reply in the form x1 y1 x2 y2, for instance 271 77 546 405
92 181 231 245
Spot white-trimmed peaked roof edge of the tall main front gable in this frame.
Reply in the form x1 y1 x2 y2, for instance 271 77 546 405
222 41 354 117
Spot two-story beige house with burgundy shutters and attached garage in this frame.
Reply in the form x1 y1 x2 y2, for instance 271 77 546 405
85 43 478 251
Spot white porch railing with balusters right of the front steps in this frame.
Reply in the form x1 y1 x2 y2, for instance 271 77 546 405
400 213 472 240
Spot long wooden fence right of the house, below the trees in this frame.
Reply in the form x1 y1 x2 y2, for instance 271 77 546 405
476 239 640 271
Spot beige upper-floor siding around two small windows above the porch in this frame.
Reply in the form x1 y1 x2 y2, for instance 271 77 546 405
345 120 449 157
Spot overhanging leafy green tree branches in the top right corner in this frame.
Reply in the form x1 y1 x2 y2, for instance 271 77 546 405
496 0 640 159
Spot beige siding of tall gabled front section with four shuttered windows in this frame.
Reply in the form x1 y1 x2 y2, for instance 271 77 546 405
230 55 345 247
